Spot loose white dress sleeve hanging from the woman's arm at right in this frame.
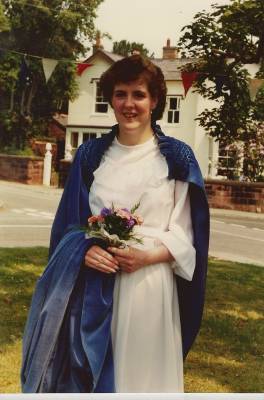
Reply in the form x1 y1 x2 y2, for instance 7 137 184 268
159 181 196 281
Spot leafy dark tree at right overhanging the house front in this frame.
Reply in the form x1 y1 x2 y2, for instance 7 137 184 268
179 0 264 180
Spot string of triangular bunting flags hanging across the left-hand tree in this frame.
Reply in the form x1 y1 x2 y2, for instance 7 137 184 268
0 47 93 84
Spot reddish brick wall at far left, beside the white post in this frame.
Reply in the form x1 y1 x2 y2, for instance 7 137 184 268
0 154 44 185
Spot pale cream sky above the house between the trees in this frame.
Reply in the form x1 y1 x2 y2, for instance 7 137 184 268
95 0 230 58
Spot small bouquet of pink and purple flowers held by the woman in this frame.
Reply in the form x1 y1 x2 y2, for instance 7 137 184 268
86 203 143 248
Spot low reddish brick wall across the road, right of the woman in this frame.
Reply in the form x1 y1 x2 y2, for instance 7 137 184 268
205 180 264 213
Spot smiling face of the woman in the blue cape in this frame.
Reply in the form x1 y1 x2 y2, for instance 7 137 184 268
112 78 157 131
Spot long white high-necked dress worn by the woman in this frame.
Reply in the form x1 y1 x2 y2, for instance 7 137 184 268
90 137 195 393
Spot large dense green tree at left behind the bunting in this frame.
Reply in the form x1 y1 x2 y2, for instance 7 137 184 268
0 0 103 148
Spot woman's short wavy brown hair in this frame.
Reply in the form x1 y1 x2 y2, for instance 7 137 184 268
99 54 167 121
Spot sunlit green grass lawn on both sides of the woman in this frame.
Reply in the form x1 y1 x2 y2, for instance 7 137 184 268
0 247 264 393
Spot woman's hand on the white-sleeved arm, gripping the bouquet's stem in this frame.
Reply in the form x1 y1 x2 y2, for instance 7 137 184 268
107 247 148 273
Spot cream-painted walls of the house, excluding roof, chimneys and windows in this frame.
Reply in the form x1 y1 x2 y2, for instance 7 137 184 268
65 55 214 176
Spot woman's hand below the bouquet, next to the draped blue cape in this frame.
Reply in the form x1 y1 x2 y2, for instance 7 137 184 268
84 245 119 274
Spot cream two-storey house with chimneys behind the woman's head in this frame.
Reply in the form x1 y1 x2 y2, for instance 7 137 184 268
65 39 218 177
